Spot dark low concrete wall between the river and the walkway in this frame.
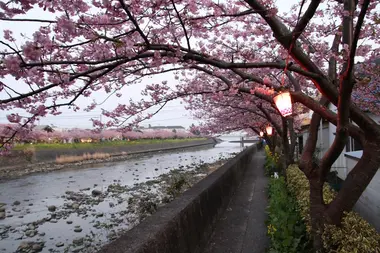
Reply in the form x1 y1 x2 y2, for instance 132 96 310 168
98 144 259 253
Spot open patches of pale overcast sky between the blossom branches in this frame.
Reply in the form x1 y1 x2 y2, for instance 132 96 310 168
0 0 296 128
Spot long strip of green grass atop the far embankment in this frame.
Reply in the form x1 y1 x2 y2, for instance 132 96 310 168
13 138 206 150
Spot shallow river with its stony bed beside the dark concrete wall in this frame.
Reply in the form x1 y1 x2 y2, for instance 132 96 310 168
0 137 250 253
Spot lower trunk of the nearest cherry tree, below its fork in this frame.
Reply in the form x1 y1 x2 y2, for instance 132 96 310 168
309 176 325 253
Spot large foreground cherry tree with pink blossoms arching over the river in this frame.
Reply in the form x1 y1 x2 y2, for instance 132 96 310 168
0 0 380 250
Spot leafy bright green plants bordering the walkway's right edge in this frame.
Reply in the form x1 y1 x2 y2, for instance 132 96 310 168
267 177 311 253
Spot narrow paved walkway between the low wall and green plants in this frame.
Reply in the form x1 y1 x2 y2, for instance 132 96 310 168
204 151 269 253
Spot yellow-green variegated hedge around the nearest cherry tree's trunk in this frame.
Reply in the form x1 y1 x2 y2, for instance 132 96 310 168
287 165 380 253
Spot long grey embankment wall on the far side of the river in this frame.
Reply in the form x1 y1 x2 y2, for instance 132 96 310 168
0 138 216 167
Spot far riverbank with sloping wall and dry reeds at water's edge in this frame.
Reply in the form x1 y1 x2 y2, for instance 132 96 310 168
0 138 218 181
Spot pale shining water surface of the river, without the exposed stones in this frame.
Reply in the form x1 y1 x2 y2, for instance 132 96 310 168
0 137 251 252
